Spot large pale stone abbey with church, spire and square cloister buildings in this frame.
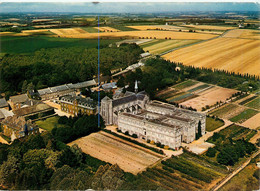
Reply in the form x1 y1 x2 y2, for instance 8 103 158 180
100 82 206 150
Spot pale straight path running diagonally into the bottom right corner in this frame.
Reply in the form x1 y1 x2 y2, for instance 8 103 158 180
211 150 260 191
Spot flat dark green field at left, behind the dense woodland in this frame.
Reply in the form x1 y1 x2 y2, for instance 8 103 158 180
1 36 117 54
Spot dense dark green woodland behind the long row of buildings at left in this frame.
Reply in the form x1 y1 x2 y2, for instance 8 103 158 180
0 44 143 95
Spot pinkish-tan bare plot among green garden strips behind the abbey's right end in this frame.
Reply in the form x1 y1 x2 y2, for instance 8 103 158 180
181 87 237 111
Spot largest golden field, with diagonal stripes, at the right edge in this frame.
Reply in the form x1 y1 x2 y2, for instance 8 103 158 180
163 38 260 76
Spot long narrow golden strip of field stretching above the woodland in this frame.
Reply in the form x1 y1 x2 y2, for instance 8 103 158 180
51 29 217 40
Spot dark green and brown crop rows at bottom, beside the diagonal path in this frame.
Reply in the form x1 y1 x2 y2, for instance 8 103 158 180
140 152 227 191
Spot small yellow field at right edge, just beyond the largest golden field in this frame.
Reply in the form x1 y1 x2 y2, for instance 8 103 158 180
223 29 260 40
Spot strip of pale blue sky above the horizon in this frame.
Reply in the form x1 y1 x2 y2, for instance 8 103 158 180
0 2 260 13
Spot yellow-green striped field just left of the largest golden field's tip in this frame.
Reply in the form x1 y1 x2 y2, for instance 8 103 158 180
143 40 199 54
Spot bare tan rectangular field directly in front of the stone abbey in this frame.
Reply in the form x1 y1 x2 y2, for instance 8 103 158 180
69 132 163 174
